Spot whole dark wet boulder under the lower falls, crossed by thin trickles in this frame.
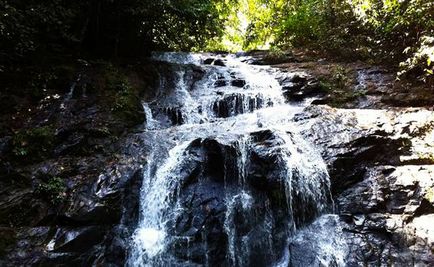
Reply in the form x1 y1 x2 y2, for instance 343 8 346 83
161 133 326 265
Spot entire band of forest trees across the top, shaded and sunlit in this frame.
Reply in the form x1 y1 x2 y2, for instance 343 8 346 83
0 0 434 79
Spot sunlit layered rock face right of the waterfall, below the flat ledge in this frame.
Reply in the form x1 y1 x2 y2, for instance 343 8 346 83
291 106 434 266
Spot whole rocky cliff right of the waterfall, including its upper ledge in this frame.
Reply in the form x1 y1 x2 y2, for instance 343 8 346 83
262 51 434 266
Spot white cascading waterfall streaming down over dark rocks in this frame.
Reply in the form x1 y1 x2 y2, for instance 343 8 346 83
127 53 340 266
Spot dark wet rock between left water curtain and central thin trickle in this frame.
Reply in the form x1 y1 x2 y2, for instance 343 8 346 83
166 139 234 263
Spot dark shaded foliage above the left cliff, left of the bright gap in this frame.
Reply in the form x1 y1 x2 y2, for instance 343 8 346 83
0 0 226 62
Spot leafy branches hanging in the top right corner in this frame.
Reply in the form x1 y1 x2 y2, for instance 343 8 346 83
353 0 434 81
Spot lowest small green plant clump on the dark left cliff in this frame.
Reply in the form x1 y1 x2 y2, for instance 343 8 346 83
35 177 66 205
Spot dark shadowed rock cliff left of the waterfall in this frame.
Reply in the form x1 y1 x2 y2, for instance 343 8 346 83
0 62 156 266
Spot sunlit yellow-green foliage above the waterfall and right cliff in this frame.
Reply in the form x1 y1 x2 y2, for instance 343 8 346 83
214 0 434 81
